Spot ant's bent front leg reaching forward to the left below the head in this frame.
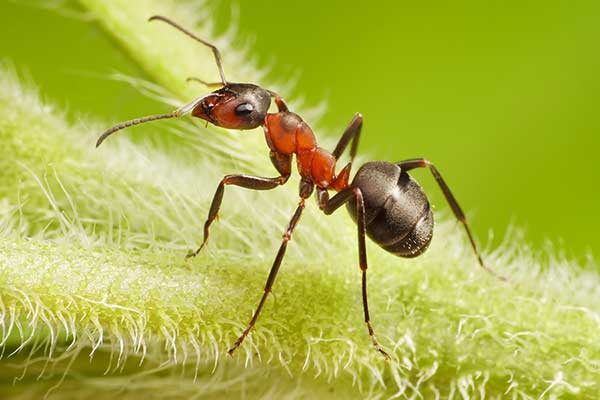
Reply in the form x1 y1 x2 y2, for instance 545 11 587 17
186 151 292 258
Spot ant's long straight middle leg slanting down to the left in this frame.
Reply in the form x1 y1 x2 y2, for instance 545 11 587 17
227 181 314 355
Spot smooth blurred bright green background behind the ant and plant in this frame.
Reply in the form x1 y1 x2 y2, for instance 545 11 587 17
0 0 600 260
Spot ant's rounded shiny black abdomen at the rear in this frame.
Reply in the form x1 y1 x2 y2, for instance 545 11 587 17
347 161 433 257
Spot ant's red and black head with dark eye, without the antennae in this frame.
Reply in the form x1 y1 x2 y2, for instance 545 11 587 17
192 83 271 129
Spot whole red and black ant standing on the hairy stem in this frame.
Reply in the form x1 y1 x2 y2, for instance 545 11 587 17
96 15 506 359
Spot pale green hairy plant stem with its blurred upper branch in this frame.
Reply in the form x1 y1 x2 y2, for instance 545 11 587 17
0 0 600 398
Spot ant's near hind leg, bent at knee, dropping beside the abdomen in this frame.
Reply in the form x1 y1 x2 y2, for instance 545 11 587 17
317 187 390 360
